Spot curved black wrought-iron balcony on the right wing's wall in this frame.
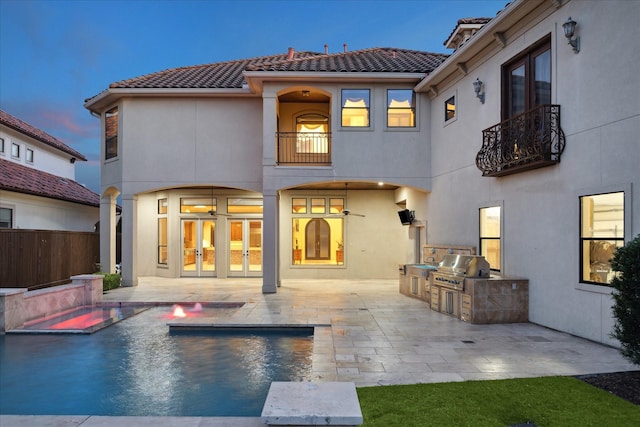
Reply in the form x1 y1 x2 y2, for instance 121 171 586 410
476 105 565 177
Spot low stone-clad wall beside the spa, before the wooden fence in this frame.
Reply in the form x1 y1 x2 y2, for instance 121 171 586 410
0 274 103 333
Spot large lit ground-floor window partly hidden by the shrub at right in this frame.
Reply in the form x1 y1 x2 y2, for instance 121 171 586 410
580 191 624 285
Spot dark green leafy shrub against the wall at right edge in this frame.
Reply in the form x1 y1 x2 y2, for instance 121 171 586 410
611 235 640 365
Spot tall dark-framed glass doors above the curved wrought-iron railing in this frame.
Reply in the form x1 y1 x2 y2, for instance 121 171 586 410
502 38 551 120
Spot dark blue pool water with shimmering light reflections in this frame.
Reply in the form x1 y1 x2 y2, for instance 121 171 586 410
0 307 313 416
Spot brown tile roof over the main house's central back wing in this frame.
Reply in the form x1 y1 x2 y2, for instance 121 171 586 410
102 48 448 89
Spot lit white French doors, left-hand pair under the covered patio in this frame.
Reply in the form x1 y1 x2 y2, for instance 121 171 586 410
181 219 216 277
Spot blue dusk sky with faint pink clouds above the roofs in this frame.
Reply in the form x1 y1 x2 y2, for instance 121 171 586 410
0 0 508 193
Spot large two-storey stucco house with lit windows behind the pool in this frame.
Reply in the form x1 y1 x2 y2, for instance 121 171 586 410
85 0 640 344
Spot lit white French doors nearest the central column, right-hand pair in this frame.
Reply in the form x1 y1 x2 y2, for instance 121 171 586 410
227 219 262 277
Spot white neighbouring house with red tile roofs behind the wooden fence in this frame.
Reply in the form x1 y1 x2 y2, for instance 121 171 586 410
0 110 100 231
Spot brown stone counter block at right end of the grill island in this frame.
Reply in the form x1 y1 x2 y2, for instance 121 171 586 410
460 273 529 324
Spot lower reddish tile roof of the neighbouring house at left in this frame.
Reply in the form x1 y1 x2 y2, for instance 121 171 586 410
0 159 100 207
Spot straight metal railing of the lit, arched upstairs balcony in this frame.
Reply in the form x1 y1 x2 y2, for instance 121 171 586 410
276 132 331 166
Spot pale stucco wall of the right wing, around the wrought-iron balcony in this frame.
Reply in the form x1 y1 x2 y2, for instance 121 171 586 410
426 1 640 344
